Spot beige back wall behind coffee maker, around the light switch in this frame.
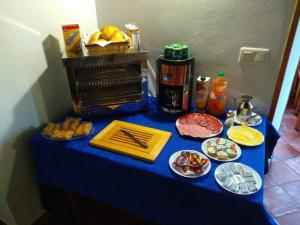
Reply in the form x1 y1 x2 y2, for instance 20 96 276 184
96 0 295 113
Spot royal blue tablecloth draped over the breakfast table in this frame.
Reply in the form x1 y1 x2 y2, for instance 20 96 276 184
30 99 275 225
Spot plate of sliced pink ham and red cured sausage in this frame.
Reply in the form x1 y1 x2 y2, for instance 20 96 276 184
176 113 223 138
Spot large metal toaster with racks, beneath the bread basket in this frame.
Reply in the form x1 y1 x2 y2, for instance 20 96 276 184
63 48 148 116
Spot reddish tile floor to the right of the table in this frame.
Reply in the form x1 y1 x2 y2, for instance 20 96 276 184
264 107 300 225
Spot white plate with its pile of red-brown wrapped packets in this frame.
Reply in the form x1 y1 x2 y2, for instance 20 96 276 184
169 150 211 178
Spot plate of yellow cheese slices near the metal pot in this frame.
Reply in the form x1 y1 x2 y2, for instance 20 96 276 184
227 126 265 146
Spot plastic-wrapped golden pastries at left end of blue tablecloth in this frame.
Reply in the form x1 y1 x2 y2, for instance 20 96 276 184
42 117 93 141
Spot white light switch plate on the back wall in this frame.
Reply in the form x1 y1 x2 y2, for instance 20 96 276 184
239 47 270 64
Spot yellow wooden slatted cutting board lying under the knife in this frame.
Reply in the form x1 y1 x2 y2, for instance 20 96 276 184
90 120 172 162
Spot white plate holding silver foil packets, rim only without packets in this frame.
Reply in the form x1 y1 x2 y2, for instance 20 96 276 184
215 162 262 195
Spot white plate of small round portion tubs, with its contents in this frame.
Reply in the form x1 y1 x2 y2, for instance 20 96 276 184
201 138 242 162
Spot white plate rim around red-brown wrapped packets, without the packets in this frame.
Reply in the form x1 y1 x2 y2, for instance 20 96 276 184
169 150 211 178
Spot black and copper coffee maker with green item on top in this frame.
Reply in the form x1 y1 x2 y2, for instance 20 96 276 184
157 44 195 113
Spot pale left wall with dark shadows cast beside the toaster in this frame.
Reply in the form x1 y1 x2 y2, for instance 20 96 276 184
0 0 97 225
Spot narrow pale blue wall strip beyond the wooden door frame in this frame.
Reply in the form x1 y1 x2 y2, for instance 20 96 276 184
272 20 300 130
